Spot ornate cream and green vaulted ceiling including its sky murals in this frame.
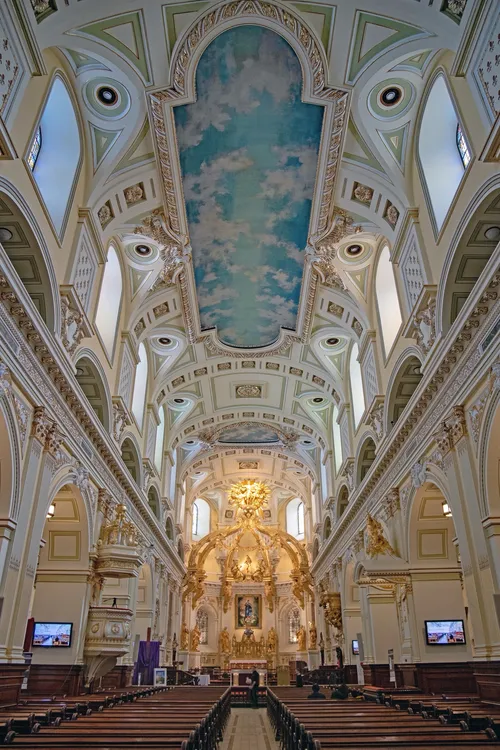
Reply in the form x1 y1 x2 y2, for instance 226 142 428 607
30 0 467 506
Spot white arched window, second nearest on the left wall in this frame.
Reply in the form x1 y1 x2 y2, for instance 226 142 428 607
95 245 123 358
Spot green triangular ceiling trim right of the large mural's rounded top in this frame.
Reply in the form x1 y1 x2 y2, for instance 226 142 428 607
346 11 434 84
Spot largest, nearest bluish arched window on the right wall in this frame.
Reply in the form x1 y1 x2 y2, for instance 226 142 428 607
418 75 470 231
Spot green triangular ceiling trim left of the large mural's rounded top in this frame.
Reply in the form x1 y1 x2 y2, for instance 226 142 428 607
67 10 153 85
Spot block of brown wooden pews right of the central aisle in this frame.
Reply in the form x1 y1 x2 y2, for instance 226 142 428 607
267 687 500 750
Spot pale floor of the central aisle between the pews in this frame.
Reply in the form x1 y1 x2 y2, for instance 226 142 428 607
222 708 278 750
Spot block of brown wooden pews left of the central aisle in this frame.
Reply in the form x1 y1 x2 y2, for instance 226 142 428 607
0 686 231 750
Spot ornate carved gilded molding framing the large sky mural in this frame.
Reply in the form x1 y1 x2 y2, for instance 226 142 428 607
143 0 349 357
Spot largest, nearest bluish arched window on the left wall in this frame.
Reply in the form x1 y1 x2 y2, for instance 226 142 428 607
26 77 81 236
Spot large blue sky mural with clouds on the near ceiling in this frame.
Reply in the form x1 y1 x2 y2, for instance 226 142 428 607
175 26 323 347
